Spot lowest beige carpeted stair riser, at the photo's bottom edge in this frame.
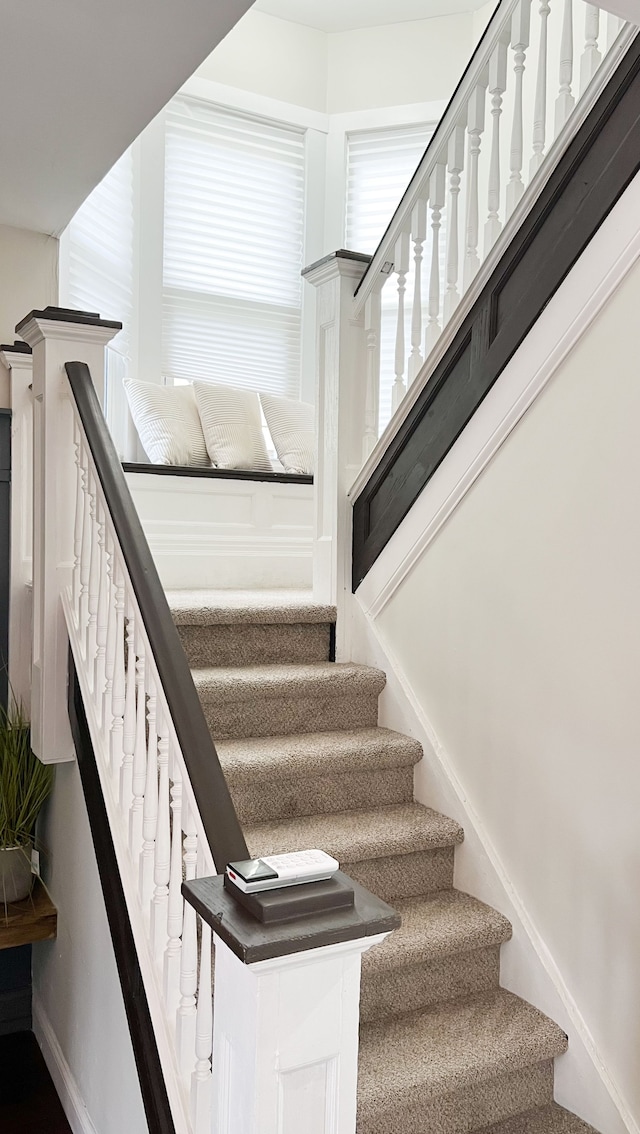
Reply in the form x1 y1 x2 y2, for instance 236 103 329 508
356 1060 554 1134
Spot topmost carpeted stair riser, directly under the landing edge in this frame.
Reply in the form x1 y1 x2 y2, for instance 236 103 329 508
178 623 330 668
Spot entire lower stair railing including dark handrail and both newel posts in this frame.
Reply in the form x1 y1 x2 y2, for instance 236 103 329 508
19 308 399 1134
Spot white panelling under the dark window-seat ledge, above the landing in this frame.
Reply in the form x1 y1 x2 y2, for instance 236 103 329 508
127 473 313 589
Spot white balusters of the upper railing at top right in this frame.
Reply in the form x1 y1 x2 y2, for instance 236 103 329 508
353 0 634 462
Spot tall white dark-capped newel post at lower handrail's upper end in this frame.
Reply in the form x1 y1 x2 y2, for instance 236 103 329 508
16 307 120 763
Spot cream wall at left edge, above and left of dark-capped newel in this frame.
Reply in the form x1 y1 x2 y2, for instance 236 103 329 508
0 225 58 406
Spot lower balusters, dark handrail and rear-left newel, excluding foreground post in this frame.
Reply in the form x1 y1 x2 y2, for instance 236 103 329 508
11 308 247 1134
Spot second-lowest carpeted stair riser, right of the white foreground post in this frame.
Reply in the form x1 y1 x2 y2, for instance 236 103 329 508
360 946 500 1022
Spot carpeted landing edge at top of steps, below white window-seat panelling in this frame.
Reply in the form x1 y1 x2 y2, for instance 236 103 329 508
167 590 336 626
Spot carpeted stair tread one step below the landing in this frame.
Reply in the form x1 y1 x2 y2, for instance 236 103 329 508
192 661 386 702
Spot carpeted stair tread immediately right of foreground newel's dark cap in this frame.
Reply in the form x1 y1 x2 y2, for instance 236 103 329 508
362 890 512 979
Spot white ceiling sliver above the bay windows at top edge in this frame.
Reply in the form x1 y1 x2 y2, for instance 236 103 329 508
254 0 487 32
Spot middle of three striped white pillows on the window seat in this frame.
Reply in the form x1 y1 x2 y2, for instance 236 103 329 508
193 382 273 473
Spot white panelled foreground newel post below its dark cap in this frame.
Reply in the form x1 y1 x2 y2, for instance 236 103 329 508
212 933 386 1134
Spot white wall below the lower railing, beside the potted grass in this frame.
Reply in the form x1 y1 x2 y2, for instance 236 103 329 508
33 763 148 1134
